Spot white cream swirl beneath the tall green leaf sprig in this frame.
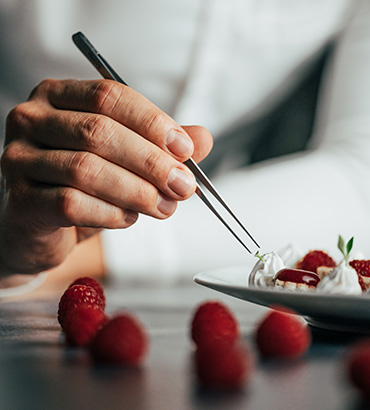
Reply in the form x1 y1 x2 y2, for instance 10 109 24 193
317 261 362 295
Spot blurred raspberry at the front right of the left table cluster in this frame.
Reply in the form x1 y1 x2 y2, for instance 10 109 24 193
90 313 148 365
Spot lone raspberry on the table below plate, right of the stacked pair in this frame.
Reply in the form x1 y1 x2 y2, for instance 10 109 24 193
256 308 311 358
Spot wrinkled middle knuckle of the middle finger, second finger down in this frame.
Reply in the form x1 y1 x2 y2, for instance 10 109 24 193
80 115 113 152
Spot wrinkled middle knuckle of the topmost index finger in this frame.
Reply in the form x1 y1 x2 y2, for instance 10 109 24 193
91 80 124 113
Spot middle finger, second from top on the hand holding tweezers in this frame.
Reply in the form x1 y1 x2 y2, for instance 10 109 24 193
11 106 195 200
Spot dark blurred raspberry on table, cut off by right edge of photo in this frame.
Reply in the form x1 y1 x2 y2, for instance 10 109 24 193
347 339 370 399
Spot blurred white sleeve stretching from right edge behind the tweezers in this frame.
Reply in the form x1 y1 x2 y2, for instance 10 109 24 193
103 1 370 282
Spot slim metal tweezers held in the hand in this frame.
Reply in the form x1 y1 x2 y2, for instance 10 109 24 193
72 32 260 253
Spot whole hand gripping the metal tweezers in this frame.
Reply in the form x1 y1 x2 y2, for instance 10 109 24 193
0 80 212 274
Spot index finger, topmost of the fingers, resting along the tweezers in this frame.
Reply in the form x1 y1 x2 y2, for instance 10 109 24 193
32 80 194 162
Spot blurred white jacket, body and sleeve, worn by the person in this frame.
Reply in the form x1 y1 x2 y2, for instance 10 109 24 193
0 0 370 282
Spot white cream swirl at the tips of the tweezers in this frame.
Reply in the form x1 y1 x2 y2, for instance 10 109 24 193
249 252 285 287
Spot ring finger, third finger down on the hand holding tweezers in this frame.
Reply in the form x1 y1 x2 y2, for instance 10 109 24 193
2 143 177 219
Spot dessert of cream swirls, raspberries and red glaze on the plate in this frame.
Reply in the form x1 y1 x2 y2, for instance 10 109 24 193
249 236 370 295
